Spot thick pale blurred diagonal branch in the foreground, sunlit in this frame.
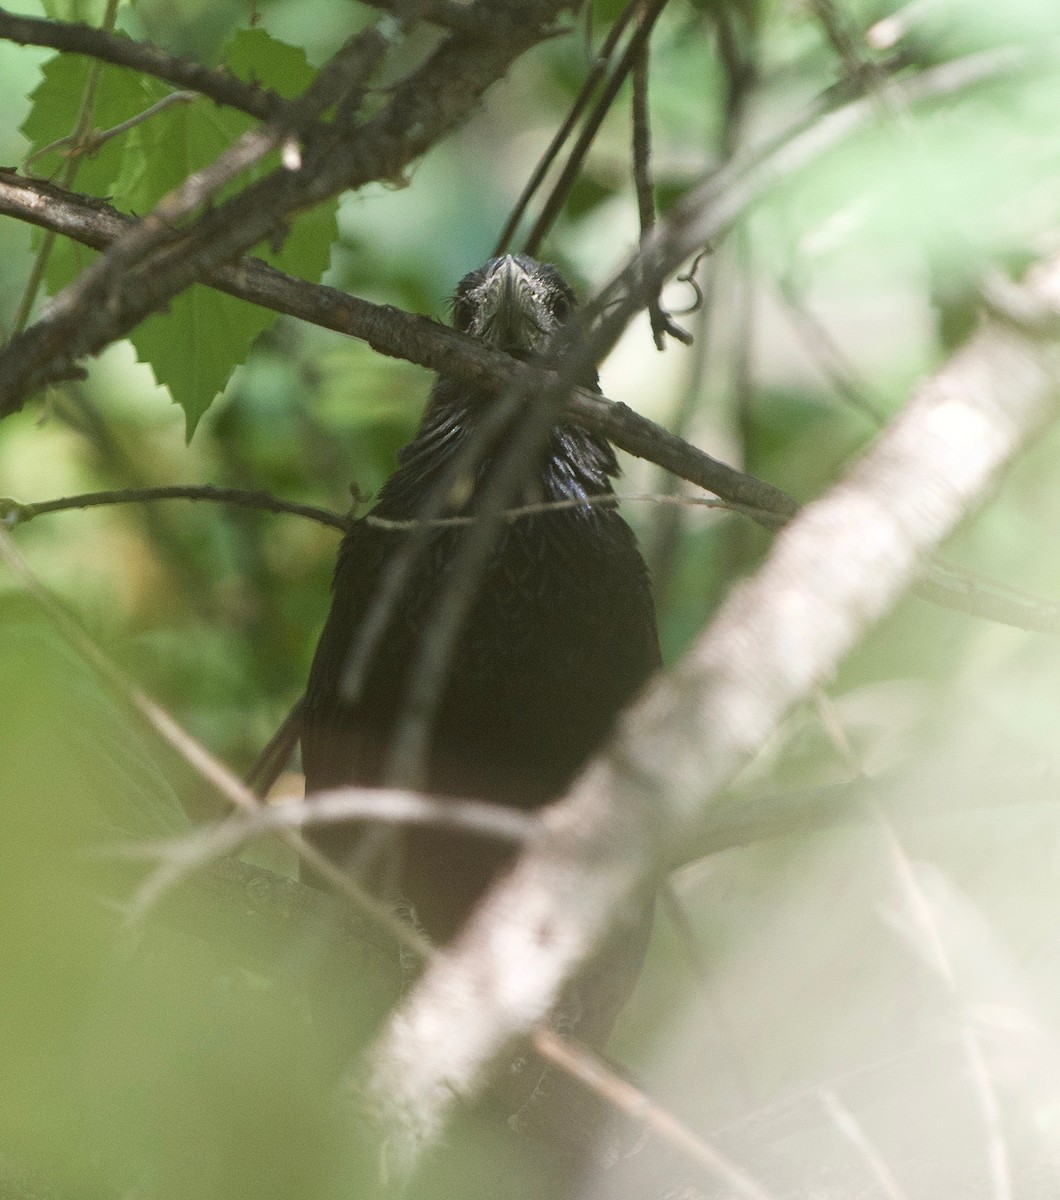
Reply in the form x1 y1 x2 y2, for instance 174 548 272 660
362 253 1060 1172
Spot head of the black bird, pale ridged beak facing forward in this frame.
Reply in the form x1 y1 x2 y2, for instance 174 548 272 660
453 254 574 359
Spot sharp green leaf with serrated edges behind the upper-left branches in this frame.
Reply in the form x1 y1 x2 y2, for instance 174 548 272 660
23 29 337 437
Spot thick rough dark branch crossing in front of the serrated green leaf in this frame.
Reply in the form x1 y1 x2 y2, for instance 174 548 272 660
0 0 581 414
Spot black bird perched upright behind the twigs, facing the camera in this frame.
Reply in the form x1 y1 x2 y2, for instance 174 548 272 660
301 256 660 1044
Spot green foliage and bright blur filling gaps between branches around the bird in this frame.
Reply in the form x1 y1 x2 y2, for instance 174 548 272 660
0 0 1060 1198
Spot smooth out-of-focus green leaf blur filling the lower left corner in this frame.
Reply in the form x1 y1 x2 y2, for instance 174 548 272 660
0 595 388 1200
